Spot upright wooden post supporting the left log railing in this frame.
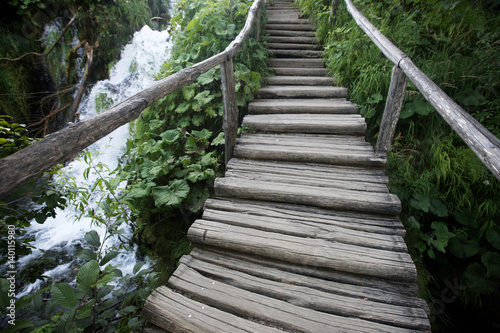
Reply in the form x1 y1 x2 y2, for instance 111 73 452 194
220 56 238 165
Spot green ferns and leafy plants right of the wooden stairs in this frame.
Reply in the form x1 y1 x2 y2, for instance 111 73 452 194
297 0 500 332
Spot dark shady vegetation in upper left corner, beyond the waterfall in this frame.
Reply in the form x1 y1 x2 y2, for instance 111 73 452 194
0 0 168 137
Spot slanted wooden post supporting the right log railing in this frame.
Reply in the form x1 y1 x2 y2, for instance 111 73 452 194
375 66 408 154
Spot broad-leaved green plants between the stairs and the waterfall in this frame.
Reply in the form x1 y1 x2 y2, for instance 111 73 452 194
0 0 267 332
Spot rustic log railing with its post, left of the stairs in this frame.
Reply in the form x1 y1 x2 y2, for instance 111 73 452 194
0 0 264 197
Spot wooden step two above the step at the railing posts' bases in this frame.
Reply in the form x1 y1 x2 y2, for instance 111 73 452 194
248 98 358 114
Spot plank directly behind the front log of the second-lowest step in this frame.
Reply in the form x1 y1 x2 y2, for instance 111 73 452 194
203 209 408 252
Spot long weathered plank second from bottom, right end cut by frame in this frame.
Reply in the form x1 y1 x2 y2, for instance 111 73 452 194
169 264 422 333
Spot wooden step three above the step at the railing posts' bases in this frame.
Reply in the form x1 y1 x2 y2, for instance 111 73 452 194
255 86 347 98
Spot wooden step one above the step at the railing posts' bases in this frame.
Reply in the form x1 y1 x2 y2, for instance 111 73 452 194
242 114 366 135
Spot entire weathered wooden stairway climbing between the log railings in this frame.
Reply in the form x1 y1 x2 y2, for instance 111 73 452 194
144 0 430 333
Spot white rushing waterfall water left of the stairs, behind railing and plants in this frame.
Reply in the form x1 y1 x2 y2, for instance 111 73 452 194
17 22 171 296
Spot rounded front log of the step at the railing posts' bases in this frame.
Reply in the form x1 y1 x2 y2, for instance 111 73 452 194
234 144 386 167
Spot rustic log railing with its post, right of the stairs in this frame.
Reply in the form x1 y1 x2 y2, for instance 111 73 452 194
332 0 500 179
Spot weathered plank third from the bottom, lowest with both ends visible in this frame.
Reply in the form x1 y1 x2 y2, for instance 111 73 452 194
181 256 430 330
